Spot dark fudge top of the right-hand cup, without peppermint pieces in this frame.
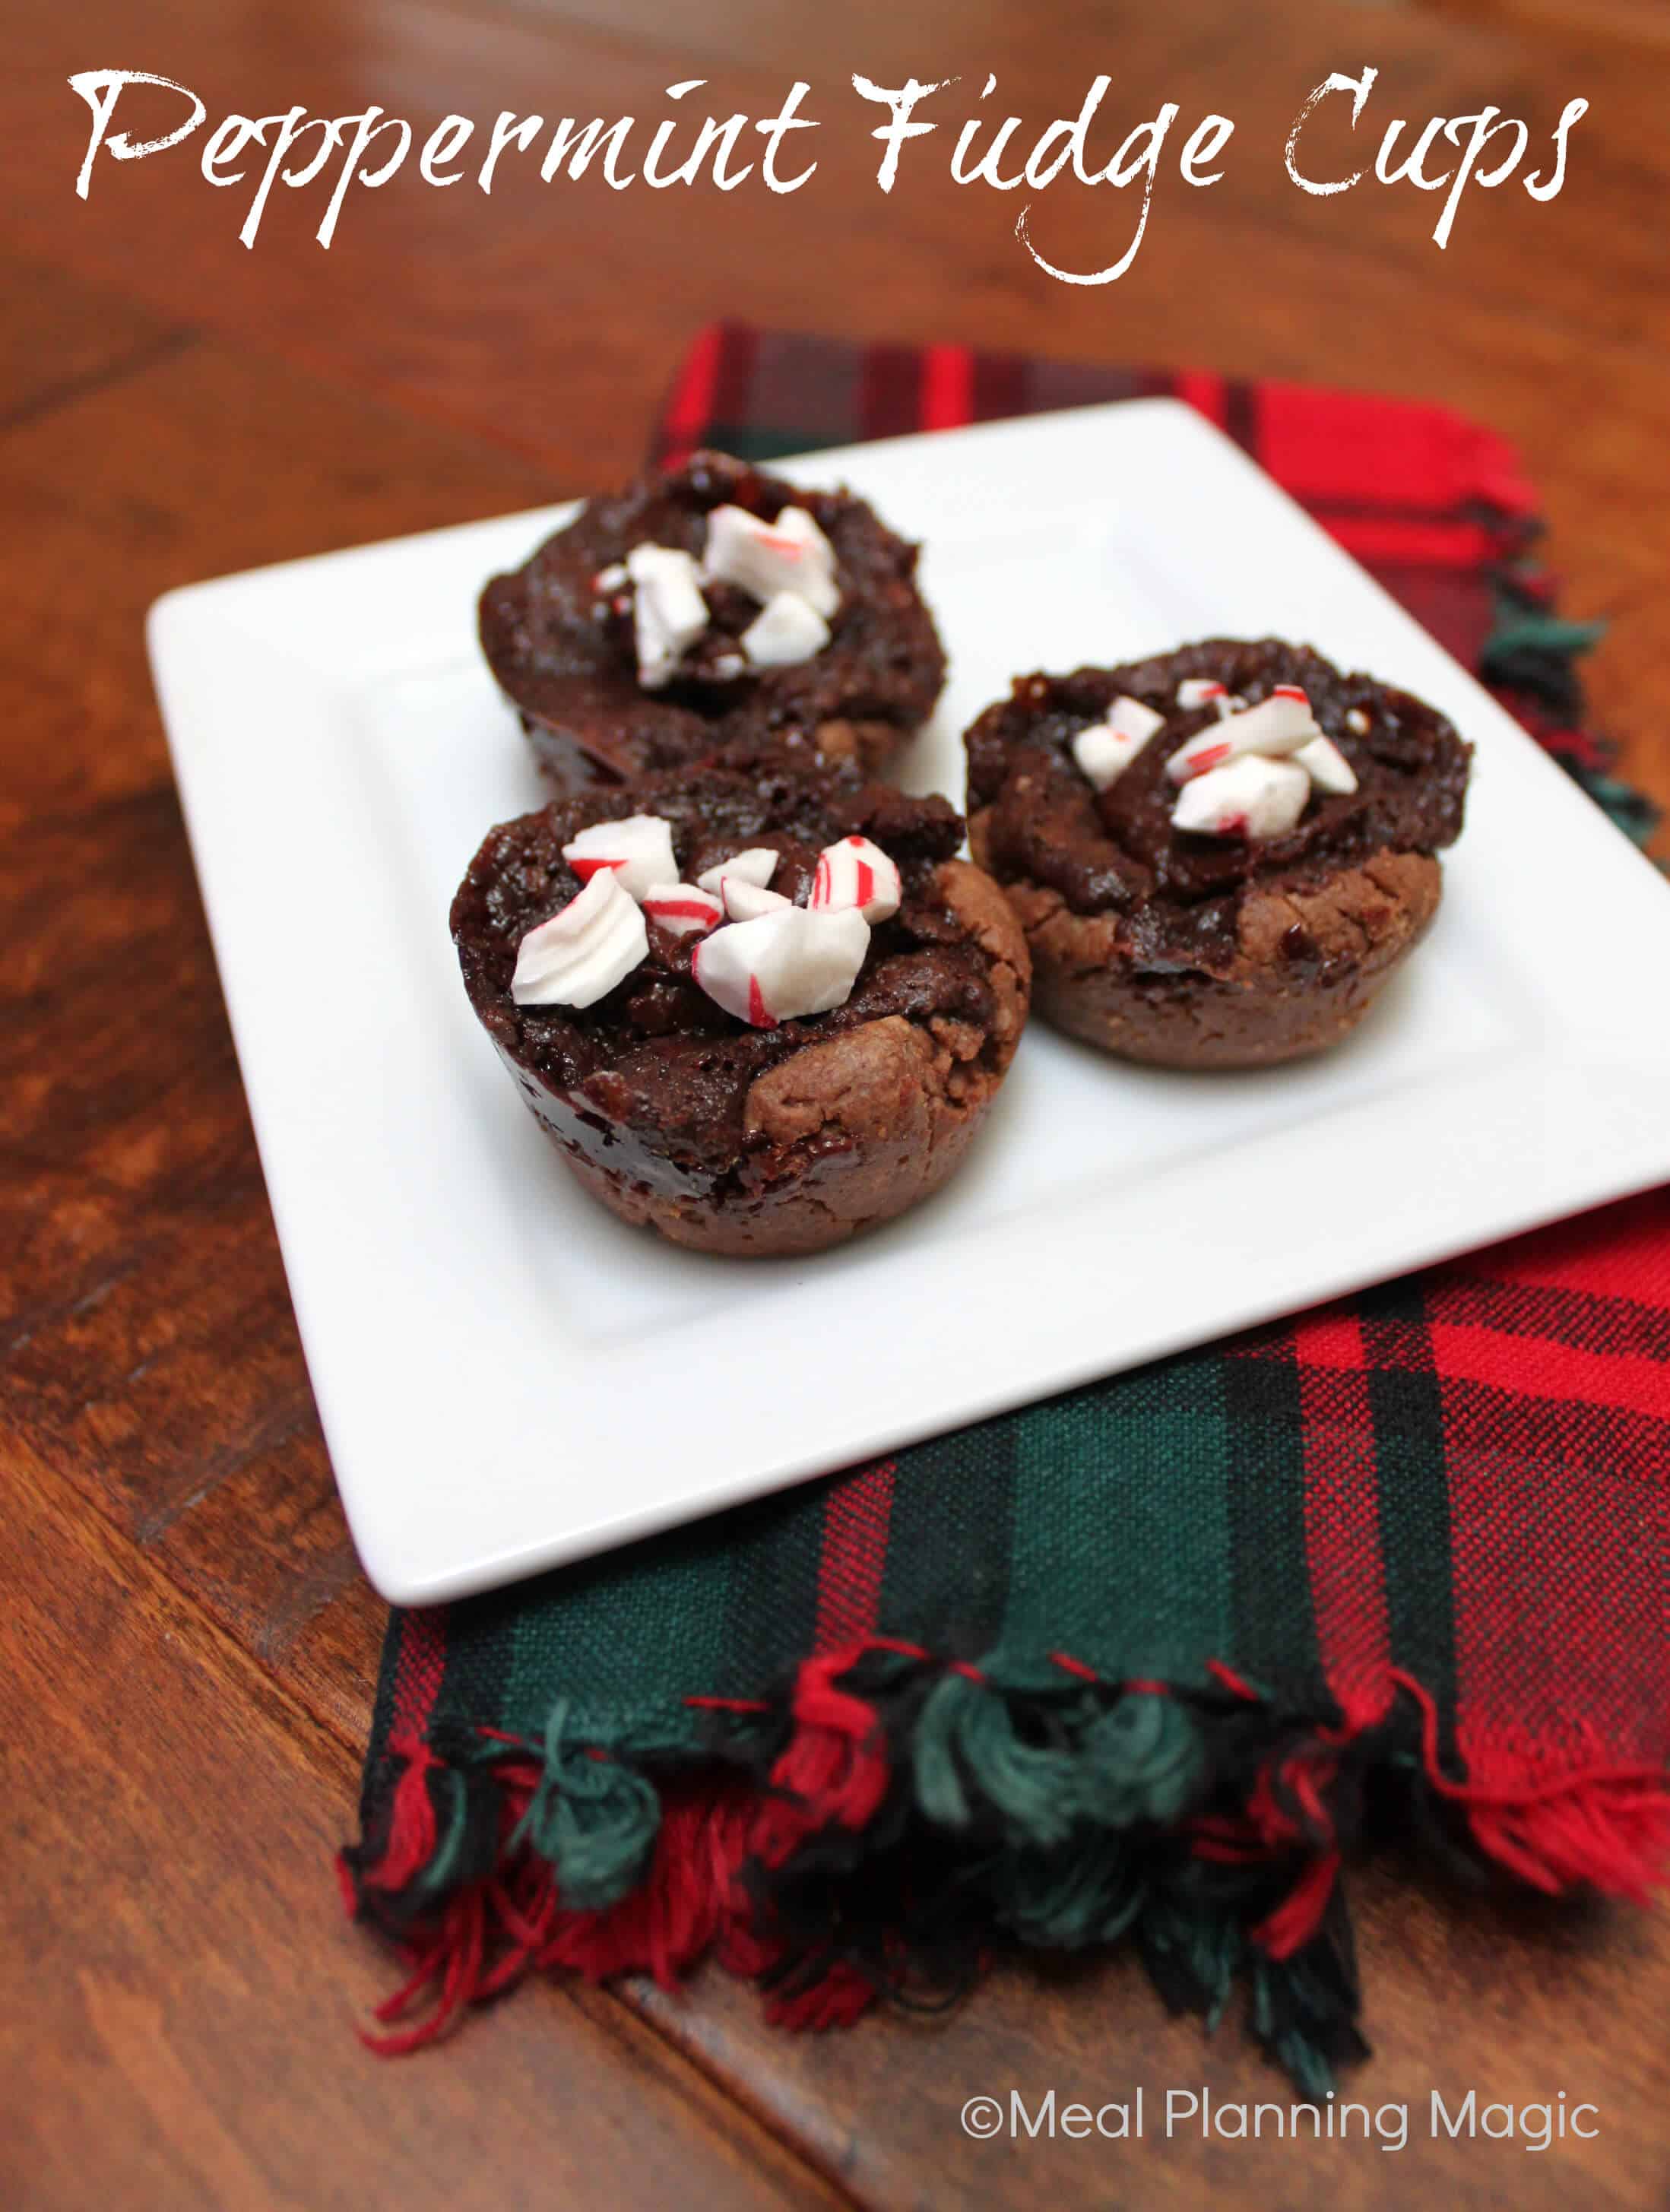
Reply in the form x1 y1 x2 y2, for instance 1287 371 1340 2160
967 637 1471 971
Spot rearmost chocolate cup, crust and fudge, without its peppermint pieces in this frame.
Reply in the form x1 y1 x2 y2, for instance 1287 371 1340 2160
480 454 945 790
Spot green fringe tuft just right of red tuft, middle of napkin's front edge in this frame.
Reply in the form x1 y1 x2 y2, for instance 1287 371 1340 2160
914 1675 1077 1849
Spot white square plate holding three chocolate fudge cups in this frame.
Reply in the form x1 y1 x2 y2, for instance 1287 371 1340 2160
151 401 1670 1602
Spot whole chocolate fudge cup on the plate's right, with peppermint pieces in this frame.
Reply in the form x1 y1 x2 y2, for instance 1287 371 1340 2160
967 637 1471 1069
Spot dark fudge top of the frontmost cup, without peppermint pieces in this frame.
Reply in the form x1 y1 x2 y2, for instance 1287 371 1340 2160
452 754 995 1188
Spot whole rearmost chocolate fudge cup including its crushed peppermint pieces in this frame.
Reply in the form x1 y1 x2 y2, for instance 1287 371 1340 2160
480 454 945 790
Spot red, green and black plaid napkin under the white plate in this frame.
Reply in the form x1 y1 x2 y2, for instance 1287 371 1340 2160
341 325 1670 2095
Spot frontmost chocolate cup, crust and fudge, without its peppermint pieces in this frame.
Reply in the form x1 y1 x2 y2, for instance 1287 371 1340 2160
452 761 1031 1254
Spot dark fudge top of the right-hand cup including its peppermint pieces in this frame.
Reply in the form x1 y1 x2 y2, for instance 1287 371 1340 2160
969 639 1469 973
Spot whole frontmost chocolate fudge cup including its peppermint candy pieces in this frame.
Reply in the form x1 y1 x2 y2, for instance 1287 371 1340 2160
452 761 1031 1257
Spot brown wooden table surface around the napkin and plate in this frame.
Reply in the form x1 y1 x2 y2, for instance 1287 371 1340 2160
0 0 1670 2212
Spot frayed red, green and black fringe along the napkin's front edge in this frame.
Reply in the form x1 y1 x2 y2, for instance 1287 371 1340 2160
341 1637 1670 2095
